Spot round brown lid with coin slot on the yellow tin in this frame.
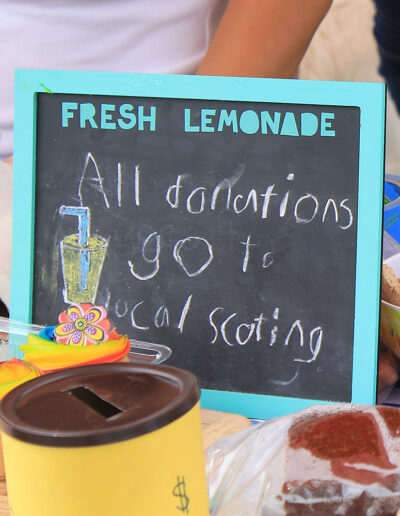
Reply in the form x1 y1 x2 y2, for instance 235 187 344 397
0 363 200 446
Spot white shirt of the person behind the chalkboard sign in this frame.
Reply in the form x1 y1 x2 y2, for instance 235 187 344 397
0 0 227 159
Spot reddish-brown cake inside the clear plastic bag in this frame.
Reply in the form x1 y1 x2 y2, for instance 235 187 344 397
282 406 400 516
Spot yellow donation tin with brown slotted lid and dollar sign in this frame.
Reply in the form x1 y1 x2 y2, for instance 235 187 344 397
0 363 209 516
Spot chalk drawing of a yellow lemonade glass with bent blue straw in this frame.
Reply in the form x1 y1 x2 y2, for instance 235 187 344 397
59 206 108 304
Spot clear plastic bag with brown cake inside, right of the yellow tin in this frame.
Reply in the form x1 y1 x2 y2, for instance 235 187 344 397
206 404 400 516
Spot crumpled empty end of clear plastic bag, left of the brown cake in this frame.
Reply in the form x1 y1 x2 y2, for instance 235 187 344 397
206 417 290 516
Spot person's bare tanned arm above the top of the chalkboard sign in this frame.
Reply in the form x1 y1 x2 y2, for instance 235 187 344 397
197 0 332 78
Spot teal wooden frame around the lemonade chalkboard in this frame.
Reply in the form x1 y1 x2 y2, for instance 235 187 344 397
10 70 386 418
